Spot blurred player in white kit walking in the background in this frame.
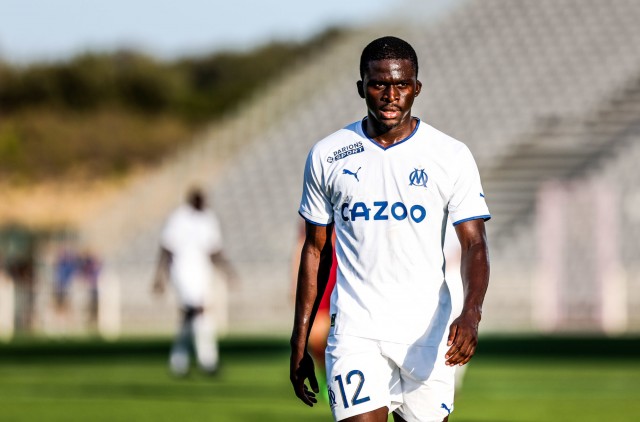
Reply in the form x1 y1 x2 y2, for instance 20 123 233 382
153 188 237 376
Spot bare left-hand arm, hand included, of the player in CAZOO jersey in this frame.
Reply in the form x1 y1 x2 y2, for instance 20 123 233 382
289 222 333 406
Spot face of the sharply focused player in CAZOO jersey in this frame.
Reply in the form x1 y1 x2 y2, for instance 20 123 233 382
358 59 422 133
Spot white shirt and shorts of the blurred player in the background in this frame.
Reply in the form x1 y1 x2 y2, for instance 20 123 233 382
160 205 222 307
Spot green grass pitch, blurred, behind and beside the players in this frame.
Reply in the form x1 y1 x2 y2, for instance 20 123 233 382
0 340 640 422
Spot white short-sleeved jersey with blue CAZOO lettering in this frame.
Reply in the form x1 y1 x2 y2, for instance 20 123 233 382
299 118 490 346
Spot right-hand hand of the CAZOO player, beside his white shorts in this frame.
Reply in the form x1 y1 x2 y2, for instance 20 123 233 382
445 312 480 366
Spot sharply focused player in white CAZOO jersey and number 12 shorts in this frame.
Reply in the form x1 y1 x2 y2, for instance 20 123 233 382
290 37 490 422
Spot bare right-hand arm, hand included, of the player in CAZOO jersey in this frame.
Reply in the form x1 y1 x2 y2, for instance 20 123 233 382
445 218 489 366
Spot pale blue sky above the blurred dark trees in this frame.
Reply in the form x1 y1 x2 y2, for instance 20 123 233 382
0 0 402 63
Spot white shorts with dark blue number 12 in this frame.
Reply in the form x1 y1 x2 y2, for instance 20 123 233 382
326 334 456 422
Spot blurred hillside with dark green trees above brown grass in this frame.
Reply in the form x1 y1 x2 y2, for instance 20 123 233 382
0 29 343 181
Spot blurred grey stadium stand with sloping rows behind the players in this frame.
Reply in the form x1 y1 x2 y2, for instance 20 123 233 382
72 0 640 333
